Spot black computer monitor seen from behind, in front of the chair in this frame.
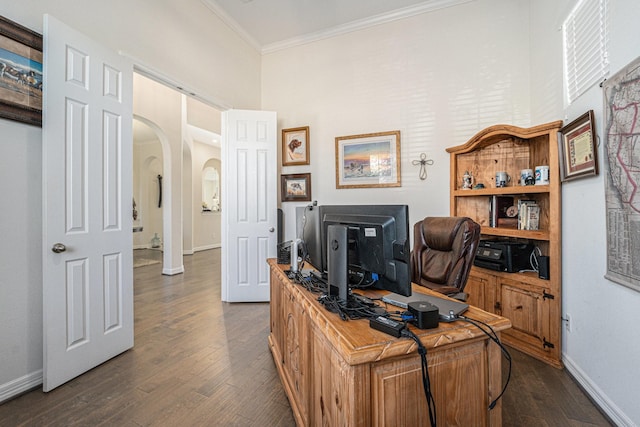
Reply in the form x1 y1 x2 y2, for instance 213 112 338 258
316 205 411 296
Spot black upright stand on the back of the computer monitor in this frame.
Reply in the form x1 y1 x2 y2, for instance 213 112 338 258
327 225 349 303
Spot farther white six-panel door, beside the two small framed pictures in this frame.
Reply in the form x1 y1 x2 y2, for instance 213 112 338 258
221 110 278 302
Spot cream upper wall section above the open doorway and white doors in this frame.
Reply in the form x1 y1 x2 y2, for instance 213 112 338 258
1 0 260 108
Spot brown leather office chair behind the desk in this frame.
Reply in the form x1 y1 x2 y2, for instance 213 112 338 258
411 217 480 301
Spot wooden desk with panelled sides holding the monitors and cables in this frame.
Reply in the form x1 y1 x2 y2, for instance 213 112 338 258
268 259 511 427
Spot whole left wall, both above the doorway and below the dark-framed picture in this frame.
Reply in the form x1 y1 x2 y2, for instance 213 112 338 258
0 0 261 401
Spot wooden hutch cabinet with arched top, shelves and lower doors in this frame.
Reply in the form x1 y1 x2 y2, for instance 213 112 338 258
447 121 562 367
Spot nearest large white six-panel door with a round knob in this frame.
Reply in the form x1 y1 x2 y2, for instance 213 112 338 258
42 16 133 391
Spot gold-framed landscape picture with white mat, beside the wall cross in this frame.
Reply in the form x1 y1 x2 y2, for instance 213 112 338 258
336 130 401 188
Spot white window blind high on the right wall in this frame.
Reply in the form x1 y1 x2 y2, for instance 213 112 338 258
562 0 609 104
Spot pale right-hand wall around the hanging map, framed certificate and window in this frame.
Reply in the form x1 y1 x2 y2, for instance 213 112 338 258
532 0 640 425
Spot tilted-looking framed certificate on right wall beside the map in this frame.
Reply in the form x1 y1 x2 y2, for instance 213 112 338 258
558 110 598 181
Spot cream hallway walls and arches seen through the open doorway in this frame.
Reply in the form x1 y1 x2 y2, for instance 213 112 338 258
133 73 222 275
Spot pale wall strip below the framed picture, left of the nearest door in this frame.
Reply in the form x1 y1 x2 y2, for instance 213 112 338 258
0 119 42 402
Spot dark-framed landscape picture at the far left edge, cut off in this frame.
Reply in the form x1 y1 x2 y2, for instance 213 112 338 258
0 16 42 126
